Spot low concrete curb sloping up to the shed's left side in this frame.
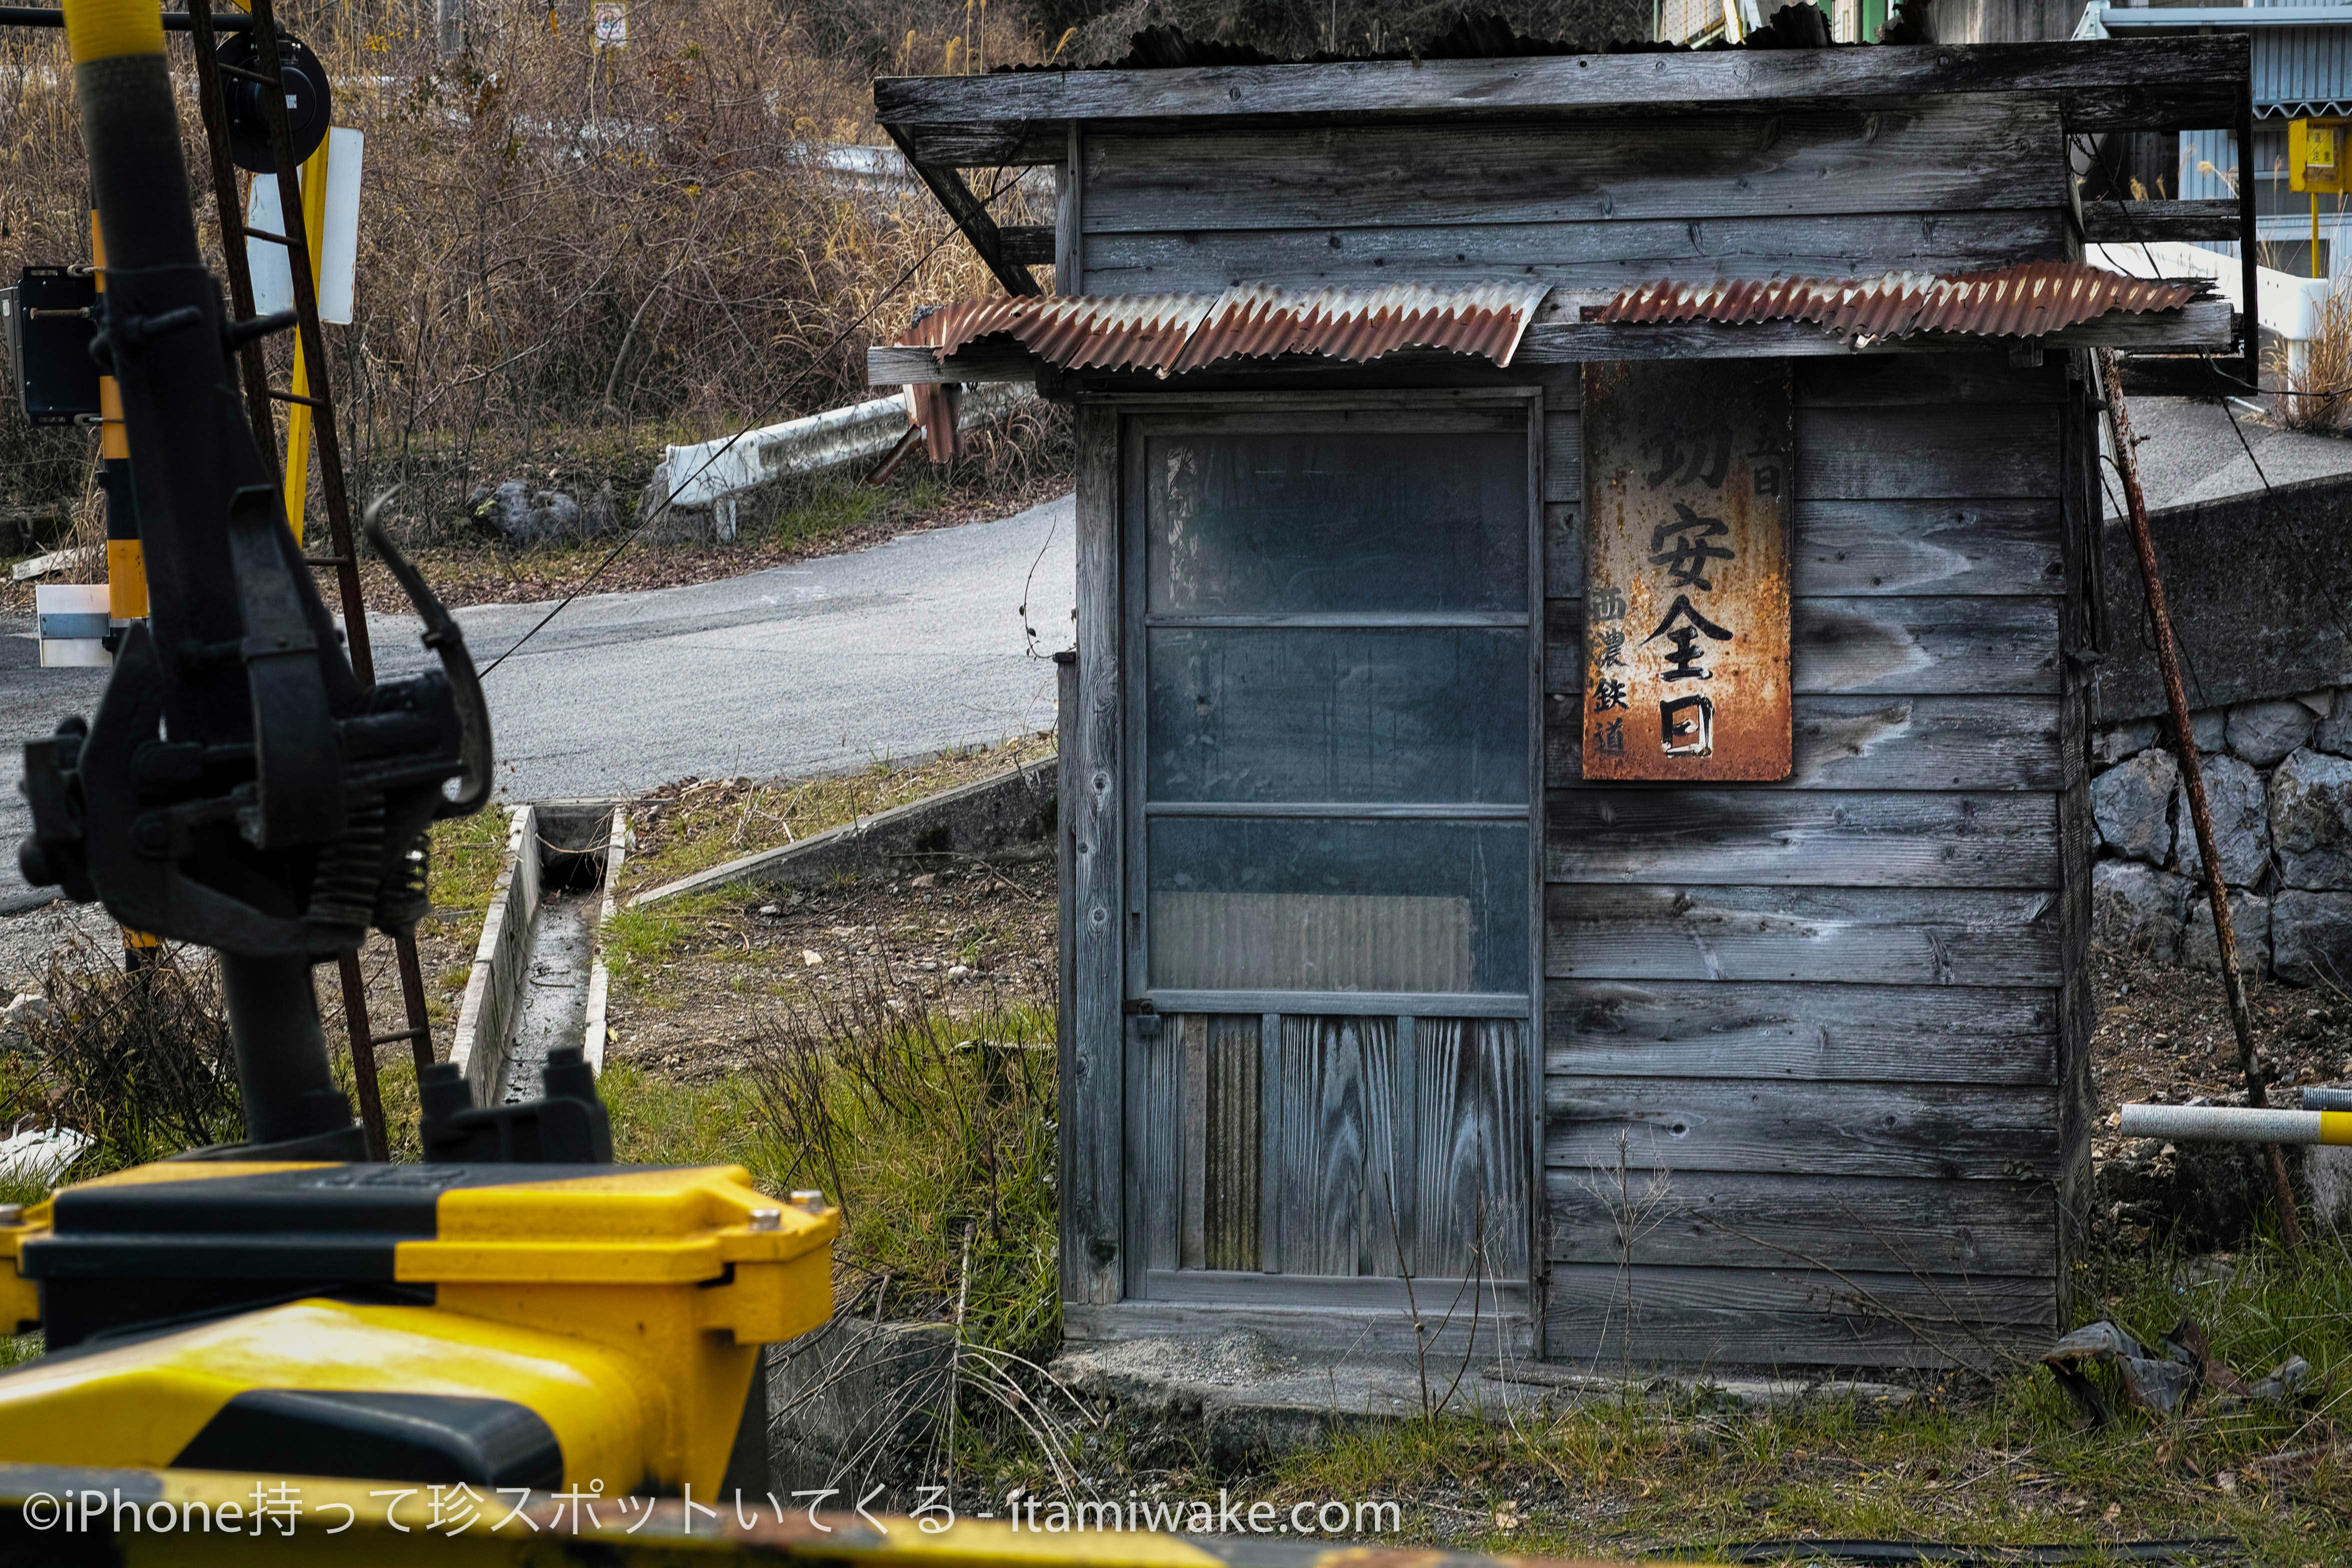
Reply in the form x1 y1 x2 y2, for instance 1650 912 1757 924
628 757 1061 910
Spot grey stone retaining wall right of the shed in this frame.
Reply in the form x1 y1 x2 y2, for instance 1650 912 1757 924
2091 689 2352 990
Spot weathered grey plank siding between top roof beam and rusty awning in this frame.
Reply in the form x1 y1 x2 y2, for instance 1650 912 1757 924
1063 92 2072 300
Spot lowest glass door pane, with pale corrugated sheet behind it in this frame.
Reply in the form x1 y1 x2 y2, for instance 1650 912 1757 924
1148 818 1529 992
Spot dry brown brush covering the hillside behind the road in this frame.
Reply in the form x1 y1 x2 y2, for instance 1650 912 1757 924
0 0 1049 538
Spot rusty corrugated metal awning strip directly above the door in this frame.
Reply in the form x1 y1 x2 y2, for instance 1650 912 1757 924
898 282 1550 376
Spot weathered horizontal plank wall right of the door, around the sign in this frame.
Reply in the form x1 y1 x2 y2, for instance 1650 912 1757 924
1543 352 2088 1366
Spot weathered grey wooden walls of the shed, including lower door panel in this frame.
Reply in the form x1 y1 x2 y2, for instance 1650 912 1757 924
1040 52 2107 1366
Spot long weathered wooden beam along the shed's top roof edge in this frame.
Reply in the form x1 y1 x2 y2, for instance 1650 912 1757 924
875 33 2251 167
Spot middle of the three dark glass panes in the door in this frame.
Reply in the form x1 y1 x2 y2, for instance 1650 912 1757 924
1146 628 1529 804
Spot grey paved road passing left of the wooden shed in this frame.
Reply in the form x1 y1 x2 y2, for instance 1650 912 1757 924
0 496 1075 910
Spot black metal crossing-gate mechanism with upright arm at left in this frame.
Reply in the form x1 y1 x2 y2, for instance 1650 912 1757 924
0 0 612 1159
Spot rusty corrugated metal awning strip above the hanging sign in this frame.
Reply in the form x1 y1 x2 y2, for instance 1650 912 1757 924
1585 261 2202 338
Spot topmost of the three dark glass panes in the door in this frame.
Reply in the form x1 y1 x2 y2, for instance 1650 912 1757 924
1146 432 1529 614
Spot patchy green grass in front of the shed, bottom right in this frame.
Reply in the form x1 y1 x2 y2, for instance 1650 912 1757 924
1162 1241 2352 1568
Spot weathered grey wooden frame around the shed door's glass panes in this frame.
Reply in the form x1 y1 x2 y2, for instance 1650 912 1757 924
1117 386 1548 1316
